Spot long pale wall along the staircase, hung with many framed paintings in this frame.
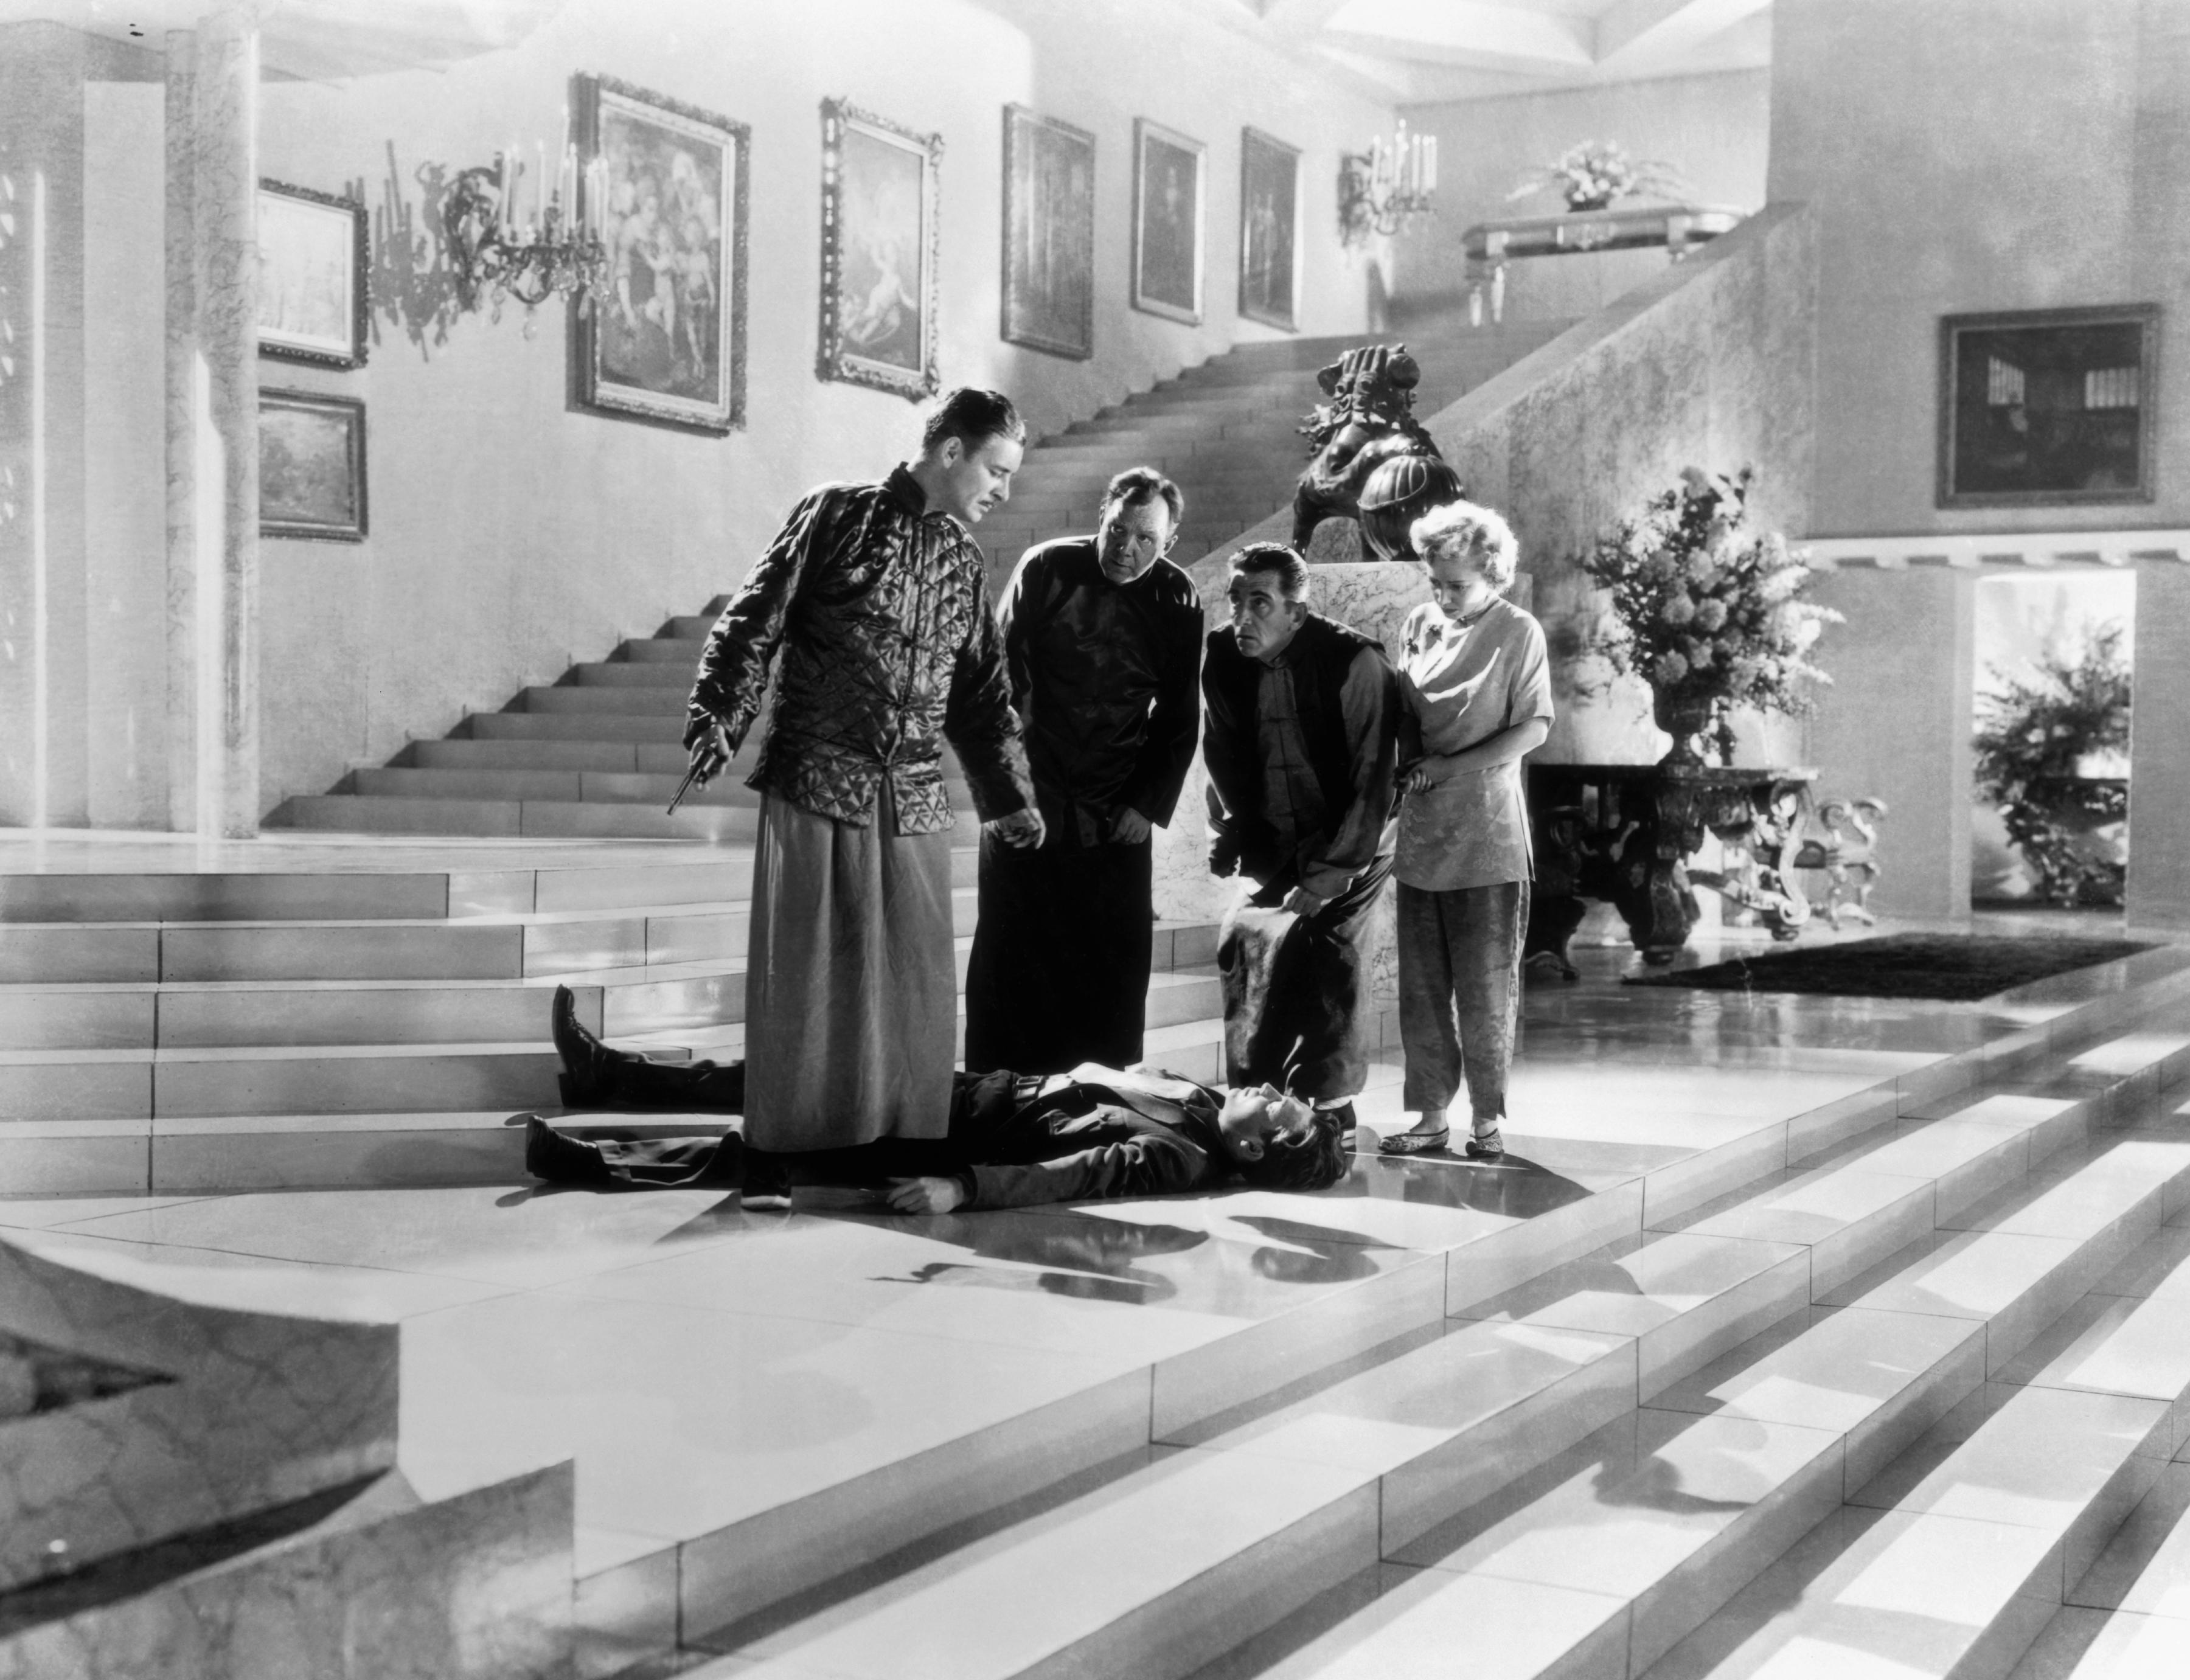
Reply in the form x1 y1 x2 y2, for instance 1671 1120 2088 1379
240 0 1391 808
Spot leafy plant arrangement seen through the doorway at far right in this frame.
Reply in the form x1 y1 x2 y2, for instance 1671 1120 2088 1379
1978 624 2131 904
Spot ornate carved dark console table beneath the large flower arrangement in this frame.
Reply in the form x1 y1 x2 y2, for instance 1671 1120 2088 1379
1524 765 1886 979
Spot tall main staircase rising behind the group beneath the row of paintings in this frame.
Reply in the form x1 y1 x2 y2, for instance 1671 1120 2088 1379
267 322 1568 841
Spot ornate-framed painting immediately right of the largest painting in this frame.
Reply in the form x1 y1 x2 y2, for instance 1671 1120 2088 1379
815 99 944 403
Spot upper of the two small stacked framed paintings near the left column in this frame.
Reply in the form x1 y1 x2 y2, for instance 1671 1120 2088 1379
259 179 366 368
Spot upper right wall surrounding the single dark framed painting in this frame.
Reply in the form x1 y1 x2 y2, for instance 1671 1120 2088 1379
1770 0 2190 535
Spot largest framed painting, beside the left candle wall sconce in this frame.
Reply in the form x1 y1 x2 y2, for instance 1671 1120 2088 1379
569 77 751 434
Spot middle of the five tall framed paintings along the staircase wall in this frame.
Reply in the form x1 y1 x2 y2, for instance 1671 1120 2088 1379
1003 105 1095 361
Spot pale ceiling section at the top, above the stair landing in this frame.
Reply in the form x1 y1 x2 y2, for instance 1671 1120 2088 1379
1231 0 1771 103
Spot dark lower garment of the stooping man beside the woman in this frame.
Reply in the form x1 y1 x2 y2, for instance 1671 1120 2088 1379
1218 856 1391 1102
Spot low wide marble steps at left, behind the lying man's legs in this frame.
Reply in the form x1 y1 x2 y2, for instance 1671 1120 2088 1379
0 843 1222 1194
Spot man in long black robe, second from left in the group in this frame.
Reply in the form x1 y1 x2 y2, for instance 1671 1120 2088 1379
966 467 1202 1074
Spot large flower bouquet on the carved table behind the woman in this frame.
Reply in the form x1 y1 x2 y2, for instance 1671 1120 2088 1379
1581 467 1840 762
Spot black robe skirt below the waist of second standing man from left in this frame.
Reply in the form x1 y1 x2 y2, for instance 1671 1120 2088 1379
966 832 1154 1074
